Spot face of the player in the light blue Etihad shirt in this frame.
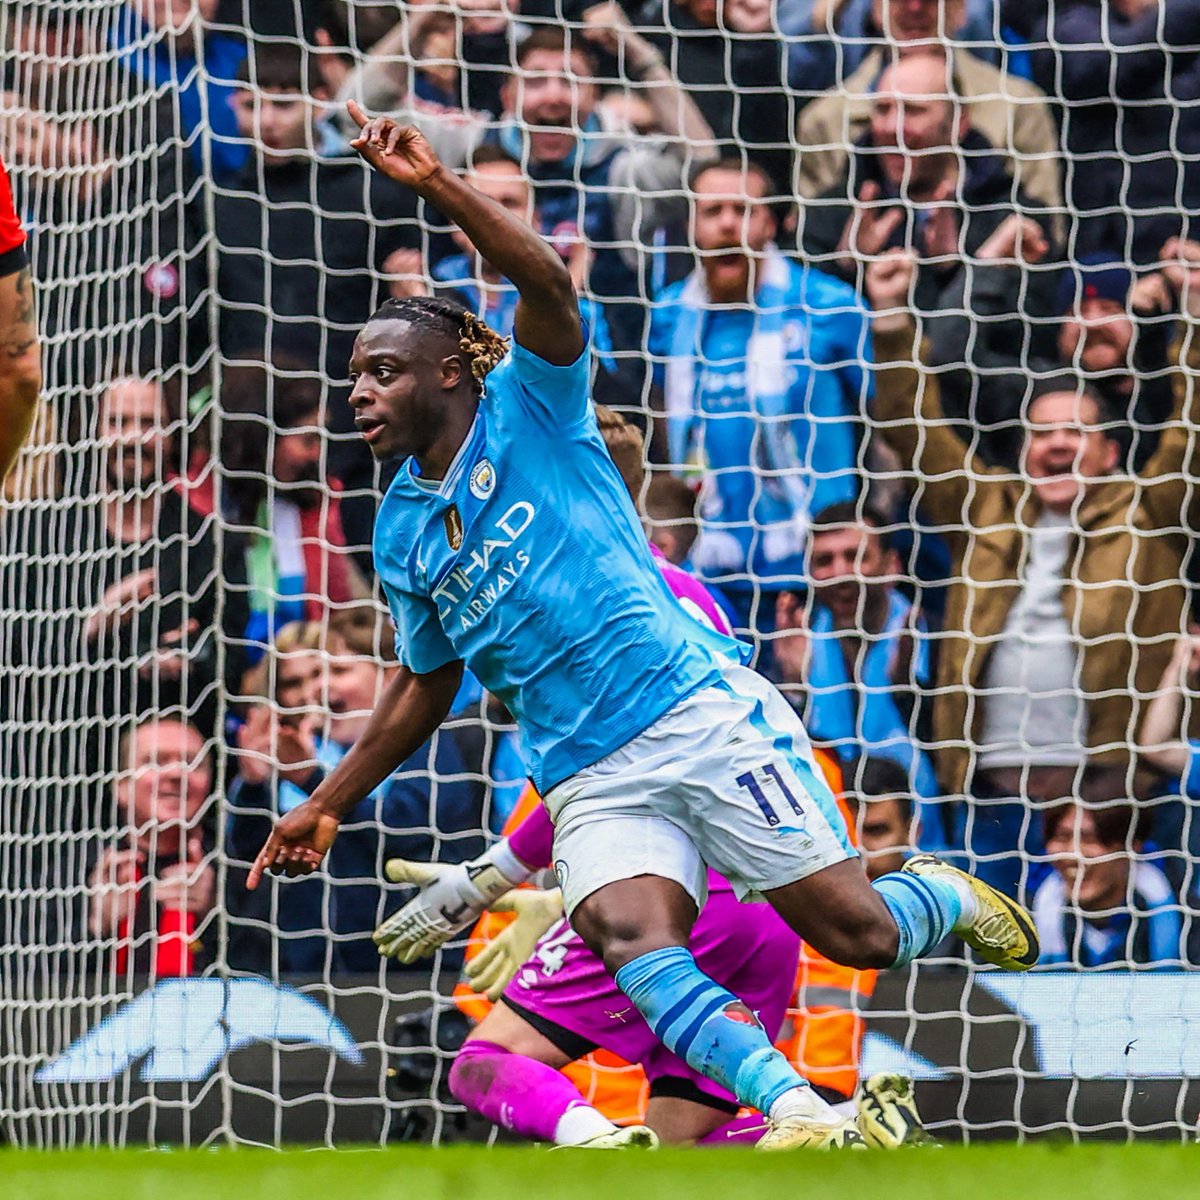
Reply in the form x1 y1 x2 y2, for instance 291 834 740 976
350 319 462 461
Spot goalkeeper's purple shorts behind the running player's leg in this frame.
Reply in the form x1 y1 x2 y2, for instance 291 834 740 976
504 871 800 1112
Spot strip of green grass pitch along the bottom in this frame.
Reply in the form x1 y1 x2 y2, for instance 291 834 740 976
0 1144 1200 1200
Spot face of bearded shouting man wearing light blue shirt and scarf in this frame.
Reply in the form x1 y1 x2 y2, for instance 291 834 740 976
691 168 775 299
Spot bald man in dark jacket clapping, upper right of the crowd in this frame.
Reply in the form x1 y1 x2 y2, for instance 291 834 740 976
802 47 1055 314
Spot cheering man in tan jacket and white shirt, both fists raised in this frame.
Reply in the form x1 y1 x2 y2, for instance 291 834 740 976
868 244 1200 894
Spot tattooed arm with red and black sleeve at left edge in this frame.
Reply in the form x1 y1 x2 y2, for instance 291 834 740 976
0 156 42 480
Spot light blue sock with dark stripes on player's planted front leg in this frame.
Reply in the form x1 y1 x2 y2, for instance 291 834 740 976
616 946 808 1112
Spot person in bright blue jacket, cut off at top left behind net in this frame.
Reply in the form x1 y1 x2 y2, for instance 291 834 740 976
108 0 247 182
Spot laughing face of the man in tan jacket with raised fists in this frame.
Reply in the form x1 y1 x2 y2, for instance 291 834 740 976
1025 391 1118 512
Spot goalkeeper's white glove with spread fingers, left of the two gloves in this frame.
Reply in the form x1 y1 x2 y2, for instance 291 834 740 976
374 841 529 962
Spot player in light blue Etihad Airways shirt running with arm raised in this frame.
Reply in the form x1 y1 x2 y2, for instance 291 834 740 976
250 107 1038 1150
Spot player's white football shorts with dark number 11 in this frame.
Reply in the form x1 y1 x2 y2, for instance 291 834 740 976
544 666 858 914
